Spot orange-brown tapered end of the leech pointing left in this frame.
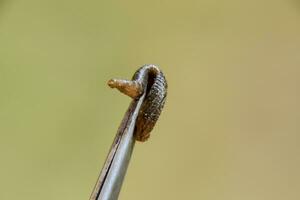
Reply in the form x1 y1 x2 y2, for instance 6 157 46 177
107 79 143 99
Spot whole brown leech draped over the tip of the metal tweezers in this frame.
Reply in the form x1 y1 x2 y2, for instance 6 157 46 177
108 65 168 142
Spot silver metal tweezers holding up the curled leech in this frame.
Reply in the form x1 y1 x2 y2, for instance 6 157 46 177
90 94 145 200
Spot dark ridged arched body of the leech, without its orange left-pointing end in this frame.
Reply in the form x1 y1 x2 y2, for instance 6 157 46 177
132 65 168 142
